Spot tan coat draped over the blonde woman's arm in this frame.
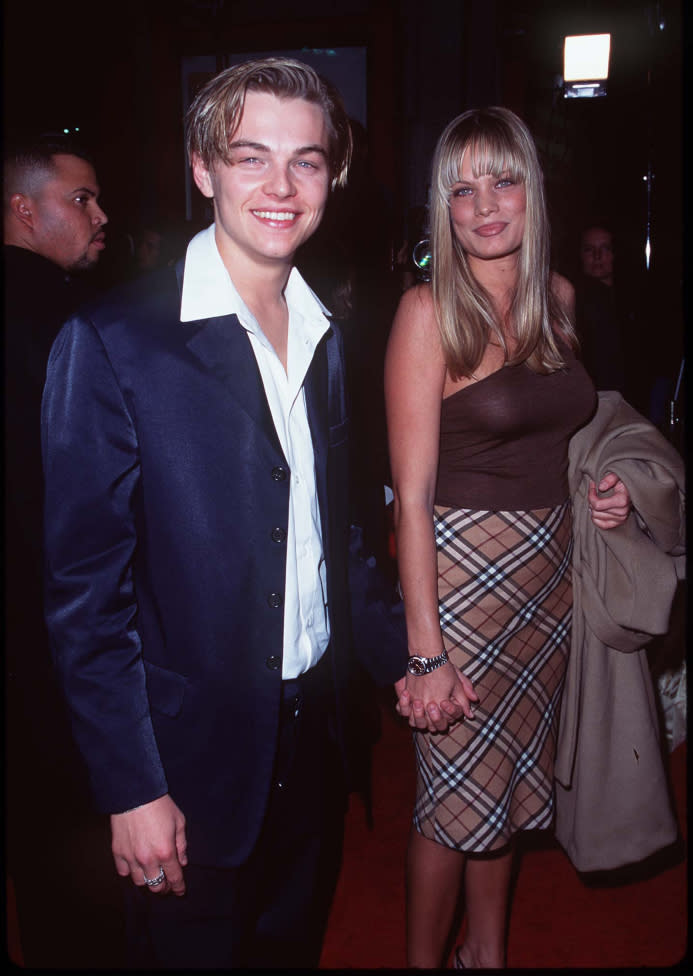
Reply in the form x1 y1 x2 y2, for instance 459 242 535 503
555 392 685 871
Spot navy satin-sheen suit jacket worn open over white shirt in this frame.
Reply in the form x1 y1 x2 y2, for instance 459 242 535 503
42 268 403 865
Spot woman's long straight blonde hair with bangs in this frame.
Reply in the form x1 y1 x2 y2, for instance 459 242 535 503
430 108 577 379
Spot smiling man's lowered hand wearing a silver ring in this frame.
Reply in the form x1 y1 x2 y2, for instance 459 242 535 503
111 794 188 895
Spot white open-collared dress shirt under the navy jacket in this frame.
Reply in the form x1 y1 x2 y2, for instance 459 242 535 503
180 224 330 678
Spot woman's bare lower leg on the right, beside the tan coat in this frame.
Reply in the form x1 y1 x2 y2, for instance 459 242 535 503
459 846 514 969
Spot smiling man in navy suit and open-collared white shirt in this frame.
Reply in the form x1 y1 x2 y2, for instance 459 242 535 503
43 59 406 969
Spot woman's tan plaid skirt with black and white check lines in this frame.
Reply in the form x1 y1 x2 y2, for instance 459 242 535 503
414 501 572 853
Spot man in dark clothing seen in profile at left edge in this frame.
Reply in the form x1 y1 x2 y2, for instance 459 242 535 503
3 139 117 968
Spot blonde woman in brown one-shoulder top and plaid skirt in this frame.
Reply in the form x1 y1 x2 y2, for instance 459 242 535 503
386 108 630 968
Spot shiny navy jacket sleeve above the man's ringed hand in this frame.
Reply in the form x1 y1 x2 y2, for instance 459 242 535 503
42 318 167 813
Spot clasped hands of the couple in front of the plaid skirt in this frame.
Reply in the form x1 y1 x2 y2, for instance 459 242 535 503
395 662 479 732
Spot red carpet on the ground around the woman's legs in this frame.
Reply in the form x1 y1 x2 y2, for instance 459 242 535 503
320 699 688 971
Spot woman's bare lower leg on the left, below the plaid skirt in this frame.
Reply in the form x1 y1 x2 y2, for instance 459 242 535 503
407 827 465 969
